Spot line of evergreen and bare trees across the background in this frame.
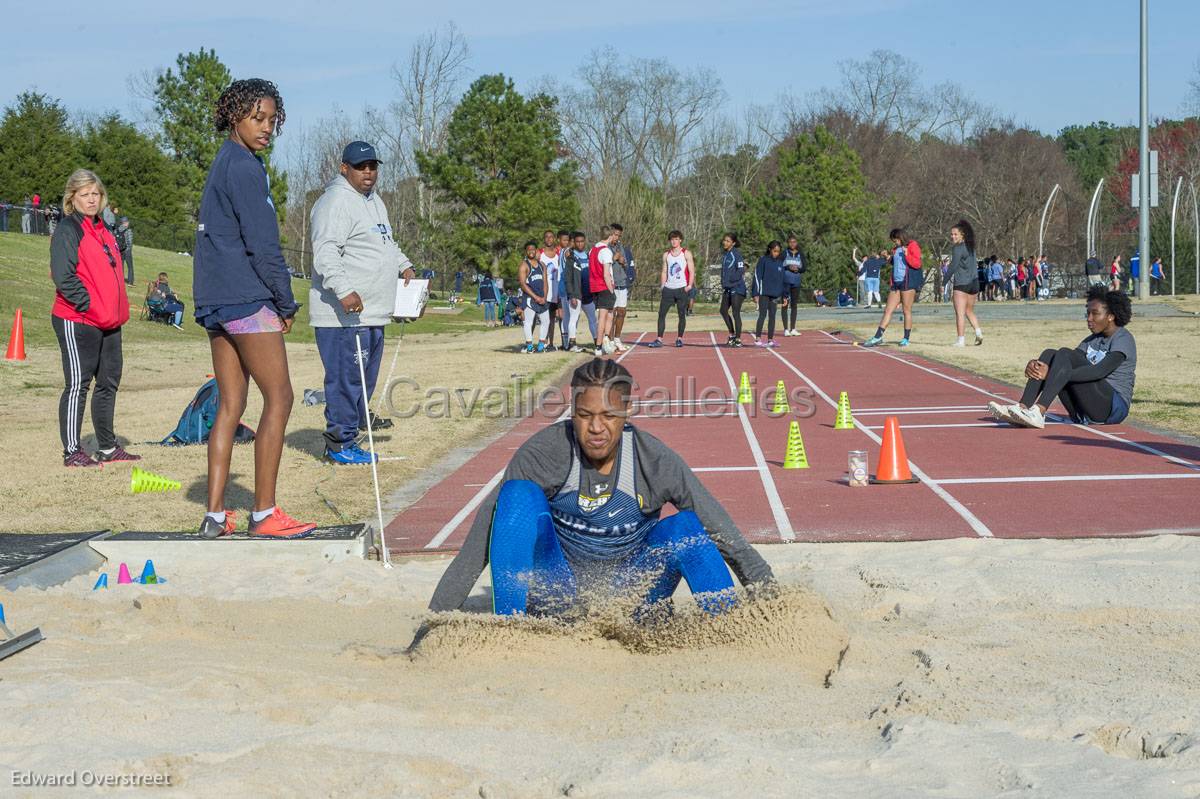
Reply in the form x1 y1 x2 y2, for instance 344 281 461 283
0 36 1200 295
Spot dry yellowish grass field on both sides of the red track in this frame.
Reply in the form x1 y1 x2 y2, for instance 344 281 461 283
0 234 1200 531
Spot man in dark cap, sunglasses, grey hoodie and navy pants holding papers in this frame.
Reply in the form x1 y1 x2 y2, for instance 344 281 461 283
308 142 414 464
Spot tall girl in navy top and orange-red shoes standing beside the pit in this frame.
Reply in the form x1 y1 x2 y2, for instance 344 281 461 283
193 78 317 539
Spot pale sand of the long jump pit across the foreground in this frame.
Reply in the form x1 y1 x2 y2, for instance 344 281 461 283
0 536 1200 799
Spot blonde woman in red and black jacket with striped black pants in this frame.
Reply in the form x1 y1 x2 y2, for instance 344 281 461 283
50 169 142 467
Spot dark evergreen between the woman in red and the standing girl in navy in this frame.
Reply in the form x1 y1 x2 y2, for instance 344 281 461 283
79 114 192 250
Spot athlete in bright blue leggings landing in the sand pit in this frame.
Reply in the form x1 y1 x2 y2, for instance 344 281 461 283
430 359 774 615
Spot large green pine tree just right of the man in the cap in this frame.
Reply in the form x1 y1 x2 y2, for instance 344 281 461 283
415 74 580 275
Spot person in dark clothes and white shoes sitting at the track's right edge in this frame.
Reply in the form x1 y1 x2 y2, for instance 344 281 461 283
988 286 1138 429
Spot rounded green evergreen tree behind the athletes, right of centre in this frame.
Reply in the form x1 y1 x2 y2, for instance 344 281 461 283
734 127 888 296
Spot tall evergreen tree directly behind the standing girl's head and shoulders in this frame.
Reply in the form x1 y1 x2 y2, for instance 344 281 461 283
155 48 288 223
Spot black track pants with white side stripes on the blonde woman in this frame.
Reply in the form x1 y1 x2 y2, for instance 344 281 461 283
50 317 122 457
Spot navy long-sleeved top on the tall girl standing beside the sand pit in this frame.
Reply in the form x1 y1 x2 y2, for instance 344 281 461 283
192 139 296 318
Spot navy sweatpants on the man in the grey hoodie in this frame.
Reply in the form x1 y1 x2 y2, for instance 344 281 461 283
314 328 383 452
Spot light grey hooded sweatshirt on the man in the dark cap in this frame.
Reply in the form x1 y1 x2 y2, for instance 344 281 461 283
308 175 413 328
